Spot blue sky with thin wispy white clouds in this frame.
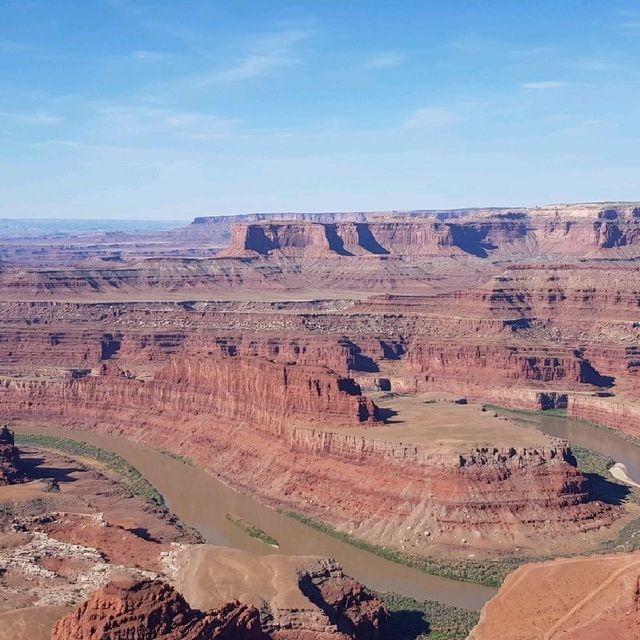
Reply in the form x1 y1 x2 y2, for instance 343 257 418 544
0 0 640 219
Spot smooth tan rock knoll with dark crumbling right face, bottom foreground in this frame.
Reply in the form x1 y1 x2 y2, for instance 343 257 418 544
165 545 389 640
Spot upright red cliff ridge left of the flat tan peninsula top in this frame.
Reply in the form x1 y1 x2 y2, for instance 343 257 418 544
0 357 378 433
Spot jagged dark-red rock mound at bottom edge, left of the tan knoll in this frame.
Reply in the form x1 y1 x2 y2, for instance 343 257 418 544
51 580 263 640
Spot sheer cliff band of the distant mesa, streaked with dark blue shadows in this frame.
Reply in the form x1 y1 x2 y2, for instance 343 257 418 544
219 208 640 258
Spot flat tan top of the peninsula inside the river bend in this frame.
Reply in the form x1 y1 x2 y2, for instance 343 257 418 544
335 393 553 453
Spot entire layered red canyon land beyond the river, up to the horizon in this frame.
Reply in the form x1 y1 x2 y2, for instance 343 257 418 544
0 203 640 636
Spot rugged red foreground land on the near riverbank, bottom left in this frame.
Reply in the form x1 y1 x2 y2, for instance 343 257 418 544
0 430 389 640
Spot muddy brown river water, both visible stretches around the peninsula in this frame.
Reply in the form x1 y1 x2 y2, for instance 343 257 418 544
16 411 640 609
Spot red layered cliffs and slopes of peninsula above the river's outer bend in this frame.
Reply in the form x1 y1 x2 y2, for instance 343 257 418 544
0 357 619 549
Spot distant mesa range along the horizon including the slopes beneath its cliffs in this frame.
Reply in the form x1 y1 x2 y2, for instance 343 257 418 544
0 203 640 299
